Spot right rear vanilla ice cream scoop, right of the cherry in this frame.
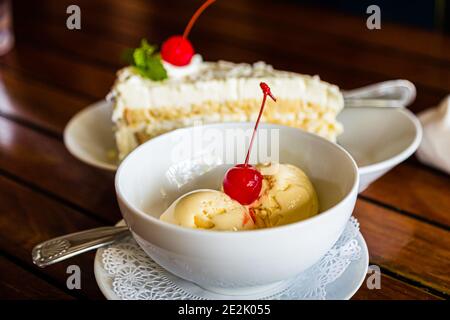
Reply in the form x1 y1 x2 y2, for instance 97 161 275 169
248 163 319 228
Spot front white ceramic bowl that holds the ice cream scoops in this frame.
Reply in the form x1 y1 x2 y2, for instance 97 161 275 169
115 123 359 294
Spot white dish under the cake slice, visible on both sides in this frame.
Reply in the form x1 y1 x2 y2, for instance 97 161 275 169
64 101 422 191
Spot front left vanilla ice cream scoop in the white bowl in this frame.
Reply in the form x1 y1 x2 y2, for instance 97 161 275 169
160 189 255 231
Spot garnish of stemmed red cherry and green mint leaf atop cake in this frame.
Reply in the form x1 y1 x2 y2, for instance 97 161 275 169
125 0 216 81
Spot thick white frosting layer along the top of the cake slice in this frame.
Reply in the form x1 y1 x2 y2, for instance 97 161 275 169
110 56 344 121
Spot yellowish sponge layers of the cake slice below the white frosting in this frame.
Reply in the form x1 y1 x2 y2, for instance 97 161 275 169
116 99 342 158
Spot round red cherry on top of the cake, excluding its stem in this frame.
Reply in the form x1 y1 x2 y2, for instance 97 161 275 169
161 36 195 67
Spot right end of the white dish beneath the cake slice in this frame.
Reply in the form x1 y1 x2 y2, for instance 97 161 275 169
338 108 422 192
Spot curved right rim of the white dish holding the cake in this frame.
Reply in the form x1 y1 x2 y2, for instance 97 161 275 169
359 108 423 174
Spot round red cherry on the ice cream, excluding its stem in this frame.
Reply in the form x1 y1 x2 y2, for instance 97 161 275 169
223 164 263 205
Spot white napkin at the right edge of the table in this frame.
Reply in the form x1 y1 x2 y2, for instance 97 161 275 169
417 95 450 174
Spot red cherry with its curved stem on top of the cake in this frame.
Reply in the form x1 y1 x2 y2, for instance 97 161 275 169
161 0 216 67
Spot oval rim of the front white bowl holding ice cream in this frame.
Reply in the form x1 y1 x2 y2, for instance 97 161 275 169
114 122 359 237
